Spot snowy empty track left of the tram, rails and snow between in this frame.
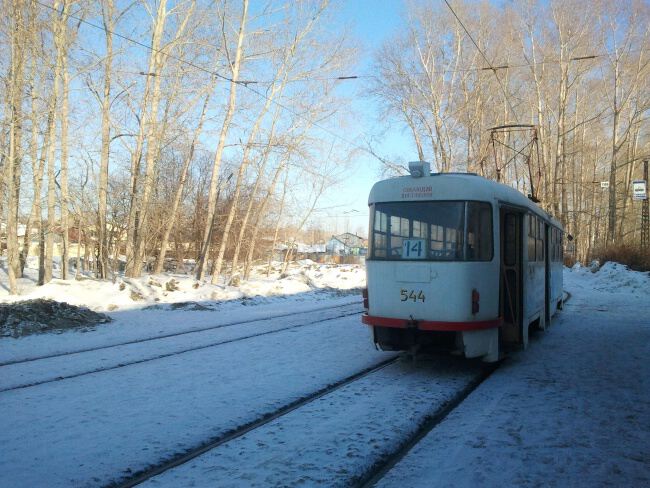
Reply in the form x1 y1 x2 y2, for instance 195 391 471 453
0 303 362 393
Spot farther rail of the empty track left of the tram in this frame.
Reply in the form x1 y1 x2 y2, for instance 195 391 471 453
0 300 361 367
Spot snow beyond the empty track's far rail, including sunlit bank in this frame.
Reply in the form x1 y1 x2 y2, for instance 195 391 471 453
0 259 365 364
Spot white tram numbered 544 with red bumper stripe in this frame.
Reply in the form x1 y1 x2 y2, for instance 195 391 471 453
362 162 562 362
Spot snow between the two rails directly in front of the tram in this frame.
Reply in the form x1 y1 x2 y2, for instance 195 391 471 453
133 355 491 487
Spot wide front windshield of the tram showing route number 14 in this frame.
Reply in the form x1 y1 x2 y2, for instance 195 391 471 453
369 201 493 261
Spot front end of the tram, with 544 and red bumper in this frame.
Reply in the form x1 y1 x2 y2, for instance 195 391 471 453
363 163 501 361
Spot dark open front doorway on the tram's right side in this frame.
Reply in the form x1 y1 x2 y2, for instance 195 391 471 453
499 208 523 345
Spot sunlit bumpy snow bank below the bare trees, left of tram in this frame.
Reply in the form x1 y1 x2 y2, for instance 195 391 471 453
0 260 365 312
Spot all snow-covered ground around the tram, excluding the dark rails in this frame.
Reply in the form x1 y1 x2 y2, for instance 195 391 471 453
0 263 650 487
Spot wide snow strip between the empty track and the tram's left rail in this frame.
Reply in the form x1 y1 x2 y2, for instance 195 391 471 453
0 310 386 487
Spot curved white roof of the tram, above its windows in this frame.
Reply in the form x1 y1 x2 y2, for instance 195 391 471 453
368 173 561 227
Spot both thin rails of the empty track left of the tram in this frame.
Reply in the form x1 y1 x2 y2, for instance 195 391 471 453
0 304 362 394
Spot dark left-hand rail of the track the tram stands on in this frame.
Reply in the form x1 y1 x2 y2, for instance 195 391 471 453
107 356 400 488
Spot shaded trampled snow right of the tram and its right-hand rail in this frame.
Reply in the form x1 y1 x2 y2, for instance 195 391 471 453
378 263 650 487
